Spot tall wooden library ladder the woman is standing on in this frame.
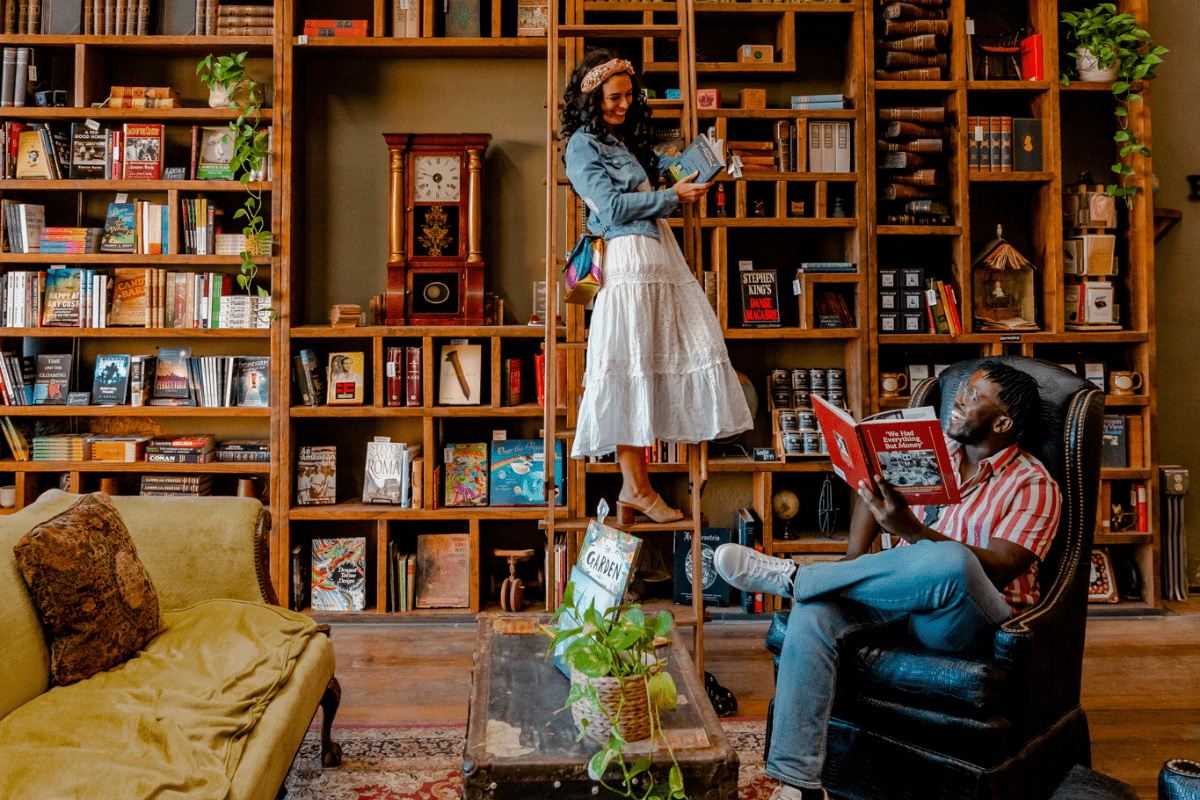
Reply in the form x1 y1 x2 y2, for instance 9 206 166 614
544 0 708 676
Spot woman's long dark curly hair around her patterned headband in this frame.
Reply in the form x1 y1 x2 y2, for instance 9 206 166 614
558 48 658 182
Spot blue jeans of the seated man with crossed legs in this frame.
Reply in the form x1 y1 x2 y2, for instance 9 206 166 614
766 541 1012 789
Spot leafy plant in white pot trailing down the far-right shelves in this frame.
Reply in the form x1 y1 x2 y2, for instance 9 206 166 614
1062 2 1166 205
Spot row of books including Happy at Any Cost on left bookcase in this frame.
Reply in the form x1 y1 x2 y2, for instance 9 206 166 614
0 266 270 330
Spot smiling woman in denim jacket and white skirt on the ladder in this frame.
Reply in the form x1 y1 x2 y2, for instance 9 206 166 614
559 49 754 524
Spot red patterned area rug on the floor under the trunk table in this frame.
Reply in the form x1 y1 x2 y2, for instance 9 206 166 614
287 718 775 800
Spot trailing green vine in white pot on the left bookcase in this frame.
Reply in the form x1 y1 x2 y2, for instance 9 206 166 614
196 53 275 319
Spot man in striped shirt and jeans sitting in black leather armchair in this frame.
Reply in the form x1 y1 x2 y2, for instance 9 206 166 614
715 361 1062 800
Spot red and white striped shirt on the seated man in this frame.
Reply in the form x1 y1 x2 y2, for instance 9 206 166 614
901 437 1062 614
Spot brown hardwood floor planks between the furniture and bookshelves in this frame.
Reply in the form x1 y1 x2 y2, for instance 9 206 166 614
321 599 1200 800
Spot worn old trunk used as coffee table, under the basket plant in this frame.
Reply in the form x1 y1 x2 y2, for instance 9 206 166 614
462 613 738 800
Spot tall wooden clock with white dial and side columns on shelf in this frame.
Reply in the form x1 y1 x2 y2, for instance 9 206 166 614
383 133 492 325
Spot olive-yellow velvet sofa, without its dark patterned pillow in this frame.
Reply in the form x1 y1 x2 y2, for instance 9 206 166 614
0 491 341 800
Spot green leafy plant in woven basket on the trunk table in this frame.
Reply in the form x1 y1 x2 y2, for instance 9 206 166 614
546 583 686 800
